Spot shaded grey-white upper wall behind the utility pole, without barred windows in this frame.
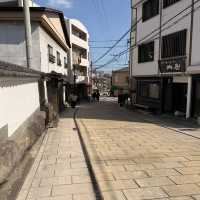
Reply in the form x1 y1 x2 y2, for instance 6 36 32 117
0 21 40 70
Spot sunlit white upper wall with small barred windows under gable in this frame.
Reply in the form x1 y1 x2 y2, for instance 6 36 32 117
39 27 68 75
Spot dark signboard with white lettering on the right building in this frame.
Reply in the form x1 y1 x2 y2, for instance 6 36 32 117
159 57 186 73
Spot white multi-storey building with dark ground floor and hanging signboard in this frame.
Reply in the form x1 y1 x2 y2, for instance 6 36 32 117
130 0 200 118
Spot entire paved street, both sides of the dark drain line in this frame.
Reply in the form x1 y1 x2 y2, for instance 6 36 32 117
17 98 200 200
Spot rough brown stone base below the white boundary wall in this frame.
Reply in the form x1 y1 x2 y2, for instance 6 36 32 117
0 109 46 184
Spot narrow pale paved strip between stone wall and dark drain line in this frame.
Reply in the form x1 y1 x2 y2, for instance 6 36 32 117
17 111 95 200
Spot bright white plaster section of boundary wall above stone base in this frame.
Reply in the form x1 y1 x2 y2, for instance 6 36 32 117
0 82 40 137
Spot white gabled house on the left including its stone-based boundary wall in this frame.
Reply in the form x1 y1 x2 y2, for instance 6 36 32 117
0 4 70 184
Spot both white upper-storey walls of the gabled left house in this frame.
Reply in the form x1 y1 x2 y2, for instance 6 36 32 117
0 21 67 75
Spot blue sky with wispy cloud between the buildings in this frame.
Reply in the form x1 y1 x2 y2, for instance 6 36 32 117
35 0 131 71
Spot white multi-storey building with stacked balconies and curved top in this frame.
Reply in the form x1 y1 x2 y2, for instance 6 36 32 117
66 19 90 98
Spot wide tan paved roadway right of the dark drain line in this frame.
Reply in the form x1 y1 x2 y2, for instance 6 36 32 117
78 99 200 200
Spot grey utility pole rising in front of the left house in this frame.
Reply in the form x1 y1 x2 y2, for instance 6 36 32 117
23 0 32 68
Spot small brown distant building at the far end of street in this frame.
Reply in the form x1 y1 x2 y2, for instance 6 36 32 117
111 67 129 96
